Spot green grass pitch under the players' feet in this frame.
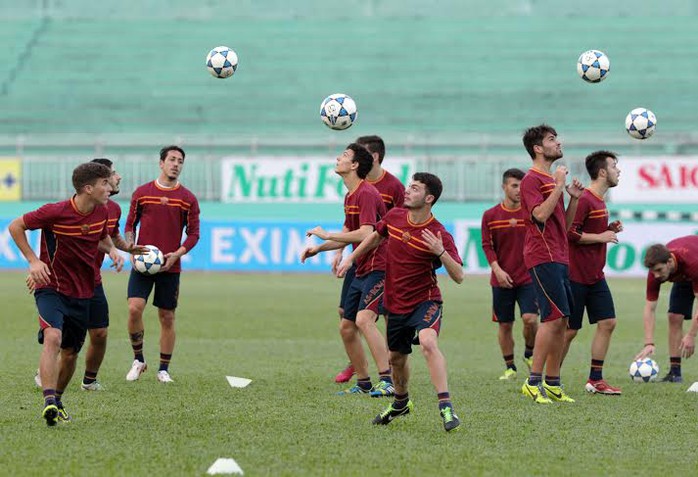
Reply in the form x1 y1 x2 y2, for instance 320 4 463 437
0 272 698 476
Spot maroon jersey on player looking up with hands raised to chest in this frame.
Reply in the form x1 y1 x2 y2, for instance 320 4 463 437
521 169 569 269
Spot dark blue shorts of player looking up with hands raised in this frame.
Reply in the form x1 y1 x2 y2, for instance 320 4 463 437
528 262 573 322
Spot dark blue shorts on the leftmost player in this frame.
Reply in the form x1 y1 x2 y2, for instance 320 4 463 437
34 288 90 353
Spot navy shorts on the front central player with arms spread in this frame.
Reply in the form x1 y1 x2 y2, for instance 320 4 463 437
387 301 443 354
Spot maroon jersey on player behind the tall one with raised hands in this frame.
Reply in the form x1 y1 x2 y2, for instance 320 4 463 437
480 204 531 287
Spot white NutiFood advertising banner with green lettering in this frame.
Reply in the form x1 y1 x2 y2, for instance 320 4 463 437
221 156 416 203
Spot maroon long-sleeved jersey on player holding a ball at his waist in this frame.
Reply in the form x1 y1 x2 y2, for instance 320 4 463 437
125 180 199 273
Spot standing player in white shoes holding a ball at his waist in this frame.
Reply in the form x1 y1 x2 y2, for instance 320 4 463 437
125 146 199 383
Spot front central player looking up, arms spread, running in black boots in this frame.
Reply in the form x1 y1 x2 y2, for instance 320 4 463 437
339 172 464 431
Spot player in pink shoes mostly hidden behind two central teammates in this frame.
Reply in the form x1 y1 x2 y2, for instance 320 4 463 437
332 136 405 383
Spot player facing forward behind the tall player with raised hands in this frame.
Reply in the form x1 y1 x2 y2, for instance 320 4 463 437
481 169 538 380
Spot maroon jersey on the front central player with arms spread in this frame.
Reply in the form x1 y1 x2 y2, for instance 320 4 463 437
376 208 463 315
